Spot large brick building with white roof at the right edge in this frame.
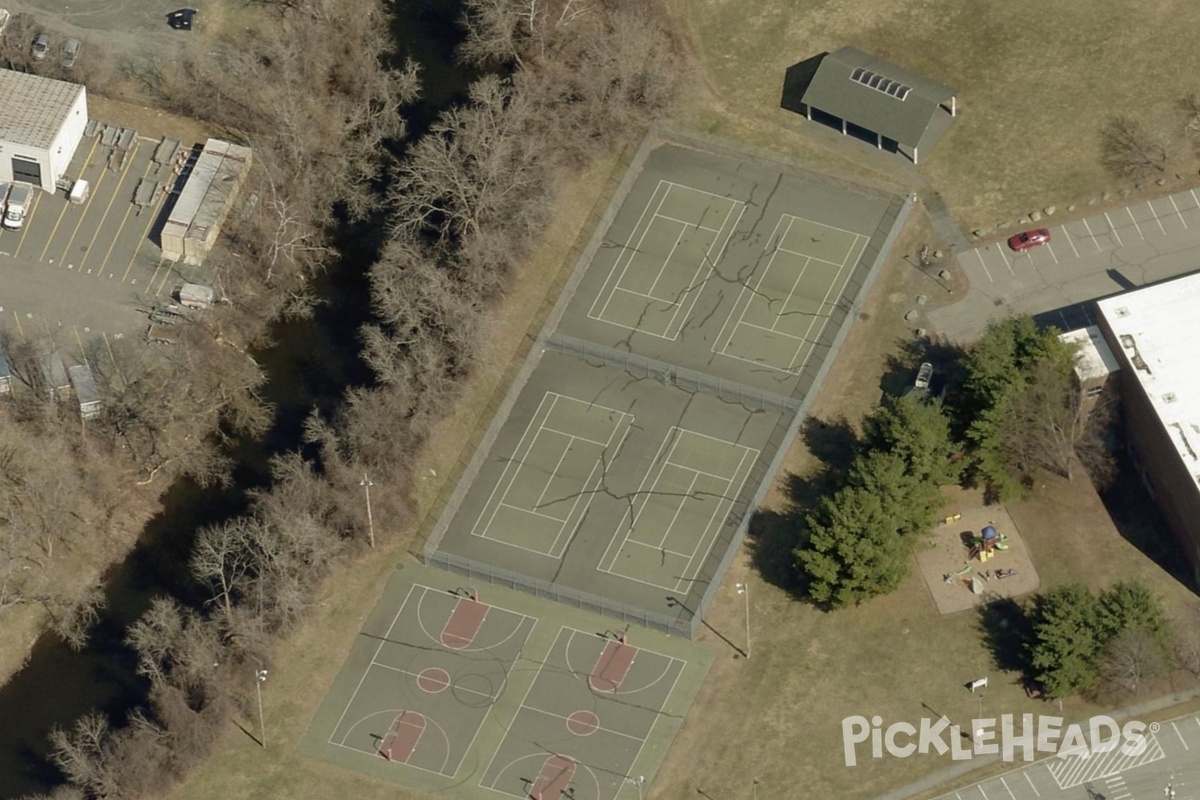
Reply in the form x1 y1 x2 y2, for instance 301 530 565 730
1097 273 1200 585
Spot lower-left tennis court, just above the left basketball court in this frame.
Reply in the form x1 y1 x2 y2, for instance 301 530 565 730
472 392 634 559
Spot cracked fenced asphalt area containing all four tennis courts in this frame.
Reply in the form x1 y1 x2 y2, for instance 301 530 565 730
426 134 904 631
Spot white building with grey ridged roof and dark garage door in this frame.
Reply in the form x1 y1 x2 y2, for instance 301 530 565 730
0 70 88 192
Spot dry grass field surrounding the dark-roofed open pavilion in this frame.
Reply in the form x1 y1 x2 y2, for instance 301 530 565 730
676 0 1198 230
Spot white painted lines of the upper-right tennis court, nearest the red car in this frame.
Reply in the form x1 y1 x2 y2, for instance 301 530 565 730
712 213 868 372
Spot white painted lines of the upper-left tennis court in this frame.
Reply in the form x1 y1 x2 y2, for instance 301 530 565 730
588 180 745 341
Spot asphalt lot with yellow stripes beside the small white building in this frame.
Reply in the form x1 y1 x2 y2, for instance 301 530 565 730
0 125 208 336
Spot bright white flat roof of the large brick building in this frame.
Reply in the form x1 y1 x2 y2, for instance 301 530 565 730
1097 273 1200 482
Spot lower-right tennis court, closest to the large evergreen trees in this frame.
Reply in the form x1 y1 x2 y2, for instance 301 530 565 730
596 427 758 593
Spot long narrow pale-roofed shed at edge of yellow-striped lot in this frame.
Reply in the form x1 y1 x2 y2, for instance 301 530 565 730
162 139 250 266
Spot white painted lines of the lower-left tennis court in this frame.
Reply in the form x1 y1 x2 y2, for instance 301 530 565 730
470 392 634 558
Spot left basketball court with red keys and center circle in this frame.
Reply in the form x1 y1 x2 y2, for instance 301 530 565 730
326 584 536 778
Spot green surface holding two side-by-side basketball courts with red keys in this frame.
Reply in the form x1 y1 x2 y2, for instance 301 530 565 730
300 565 712 800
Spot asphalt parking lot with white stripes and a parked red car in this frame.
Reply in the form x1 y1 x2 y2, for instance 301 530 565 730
929 190 1200 342
